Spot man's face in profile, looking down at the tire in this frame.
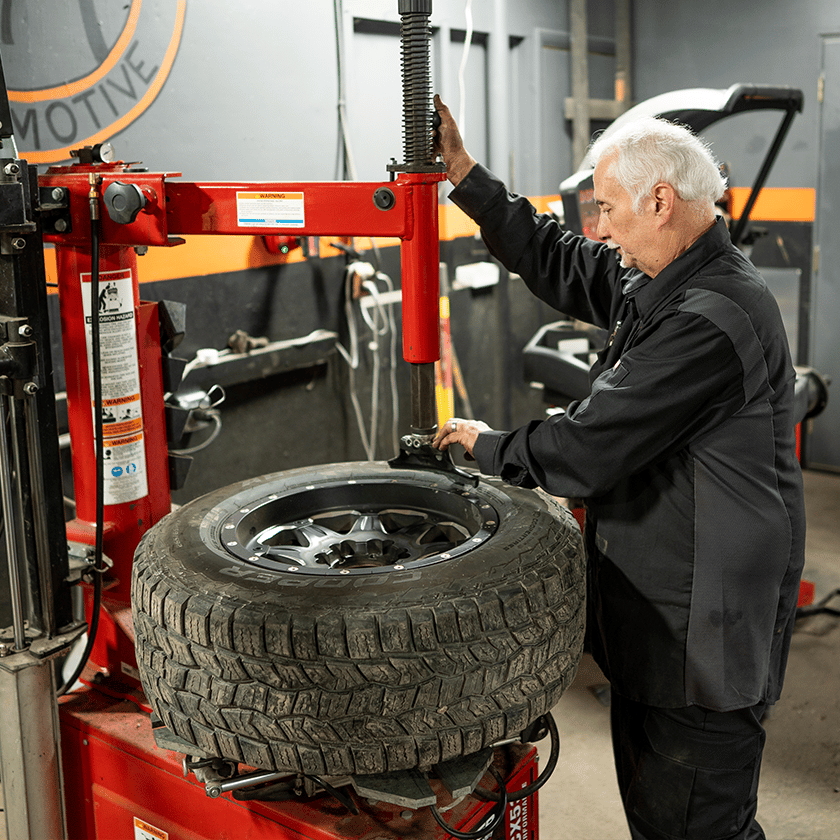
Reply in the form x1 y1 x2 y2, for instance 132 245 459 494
593 153 656 274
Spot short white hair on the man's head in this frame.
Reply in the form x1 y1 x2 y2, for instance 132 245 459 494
587 117 726 213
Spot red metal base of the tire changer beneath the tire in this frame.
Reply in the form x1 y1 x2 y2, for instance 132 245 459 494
60 689 538 840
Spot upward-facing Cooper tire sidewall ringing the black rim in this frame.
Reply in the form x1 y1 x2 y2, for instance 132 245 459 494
137 462 577 611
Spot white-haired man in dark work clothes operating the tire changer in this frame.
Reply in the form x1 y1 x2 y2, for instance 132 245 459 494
435 98 805 840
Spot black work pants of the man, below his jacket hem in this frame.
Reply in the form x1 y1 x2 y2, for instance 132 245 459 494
610 691 766 840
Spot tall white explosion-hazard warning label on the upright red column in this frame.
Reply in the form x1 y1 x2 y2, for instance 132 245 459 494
82 268 149 505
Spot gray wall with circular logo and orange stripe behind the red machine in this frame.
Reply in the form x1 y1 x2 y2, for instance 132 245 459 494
6 0 612 502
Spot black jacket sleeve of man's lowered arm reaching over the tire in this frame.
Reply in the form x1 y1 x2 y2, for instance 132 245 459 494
473 312 745 498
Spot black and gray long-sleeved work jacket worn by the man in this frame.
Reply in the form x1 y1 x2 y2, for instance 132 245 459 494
451 166 805 711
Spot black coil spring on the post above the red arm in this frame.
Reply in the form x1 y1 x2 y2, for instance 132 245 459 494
400 14 435 166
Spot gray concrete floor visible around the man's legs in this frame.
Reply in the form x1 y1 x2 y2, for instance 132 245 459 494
539 471 840 840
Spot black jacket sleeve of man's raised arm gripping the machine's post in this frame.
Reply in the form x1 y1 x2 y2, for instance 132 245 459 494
450 164 622 329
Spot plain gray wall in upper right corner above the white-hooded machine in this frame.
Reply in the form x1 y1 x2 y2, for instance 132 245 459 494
633 0 840 188
